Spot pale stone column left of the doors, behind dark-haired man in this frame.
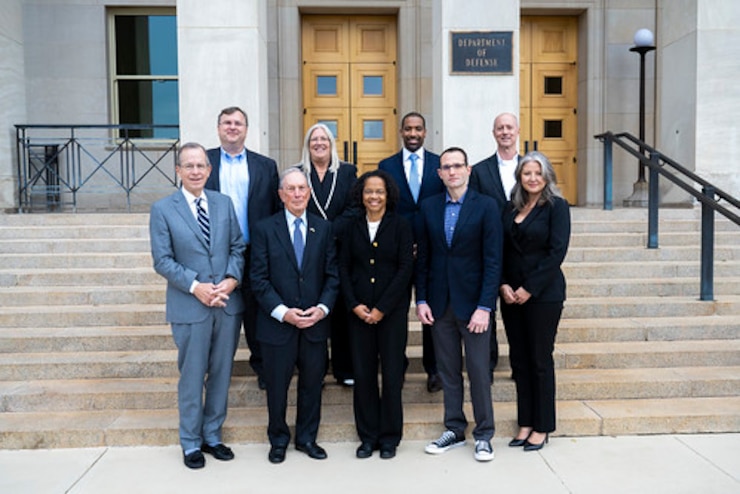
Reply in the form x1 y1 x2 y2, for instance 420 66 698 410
177 0 268 153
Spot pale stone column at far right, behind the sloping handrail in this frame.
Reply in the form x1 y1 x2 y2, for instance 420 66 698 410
657 0 740 202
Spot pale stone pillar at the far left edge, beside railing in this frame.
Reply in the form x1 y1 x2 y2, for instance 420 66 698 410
0 0 26 211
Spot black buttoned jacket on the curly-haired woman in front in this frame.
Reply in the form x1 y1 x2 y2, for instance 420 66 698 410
339 212 414 317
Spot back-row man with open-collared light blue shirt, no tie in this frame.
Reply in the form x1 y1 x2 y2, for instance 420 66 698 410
206 106 280 389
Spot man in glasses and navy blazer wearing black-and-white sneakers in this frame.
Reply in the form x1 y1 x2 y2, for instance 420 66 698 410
416 148 502 461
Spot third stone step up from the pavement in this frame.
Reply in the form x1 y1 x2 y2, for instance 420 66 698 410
0 340 740 381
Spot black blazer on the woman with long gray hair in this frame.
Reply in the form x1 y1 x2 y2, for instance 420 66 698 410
501 197 570 303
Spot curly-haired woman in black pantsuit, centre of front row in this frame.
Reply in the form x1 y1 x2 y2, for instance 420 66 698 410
339 170 414 459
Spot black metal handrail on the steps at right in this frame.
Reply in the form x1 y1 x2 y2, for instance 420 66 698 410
594 132 740 300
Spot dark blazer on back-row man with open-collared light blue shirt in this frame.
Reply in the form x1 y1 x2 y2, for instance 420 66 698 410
205 147 283 242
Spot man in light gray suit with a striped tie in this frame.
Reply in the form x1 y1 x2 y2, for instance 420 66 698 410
149 143 244 468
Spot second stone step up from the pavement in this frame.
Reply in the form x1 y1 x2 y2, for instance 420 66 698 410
5 366 740 413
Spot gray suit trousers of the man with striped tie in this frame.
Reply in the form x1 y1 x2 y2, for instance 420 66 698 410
172 309 241 451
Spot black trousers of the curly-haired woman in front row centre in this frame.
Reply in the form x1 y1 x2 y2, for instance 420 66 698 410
349 304 408 447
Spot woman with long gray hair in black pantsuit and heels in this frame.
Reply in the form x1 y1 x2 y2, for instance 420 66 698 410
500 151 570 451
